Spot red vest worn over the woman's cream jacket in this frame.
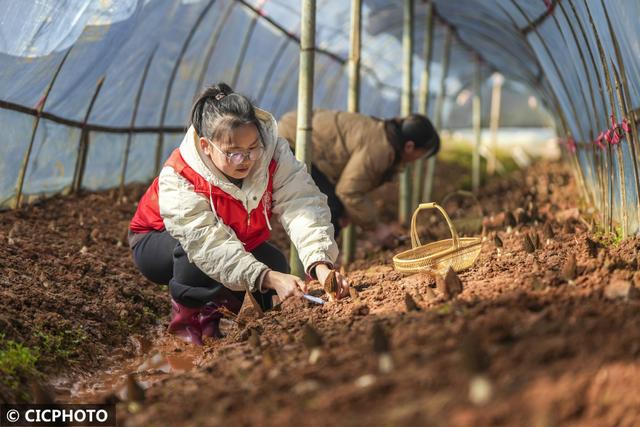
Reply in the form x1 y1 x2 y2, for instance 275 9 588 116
129 149 276 251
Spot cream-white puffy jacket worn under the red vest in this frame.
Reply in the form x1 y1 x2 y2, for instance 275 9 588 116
158 109 338 291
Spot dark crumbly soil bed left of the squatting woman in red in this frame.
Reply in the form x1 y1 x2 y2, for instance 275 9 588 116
0 187 169 402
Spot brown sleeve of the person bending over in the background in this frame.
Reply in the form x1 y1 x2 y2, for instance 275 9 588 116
336 148 393 229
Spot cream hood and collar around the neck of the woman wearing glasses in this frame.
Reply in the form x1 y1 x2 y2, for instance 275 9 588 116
179 108 278 211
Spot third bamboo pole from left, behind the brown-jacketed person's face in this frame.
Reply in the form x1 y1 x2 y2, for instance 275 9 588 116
398 0 413 226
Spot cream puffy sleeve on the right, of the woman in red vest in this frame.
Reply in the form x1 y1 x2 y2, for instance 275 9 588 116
273 138 338 275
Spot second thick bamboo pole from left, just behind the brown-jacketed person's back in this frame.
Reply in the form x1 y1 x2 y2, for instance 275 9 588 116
342 0 362 265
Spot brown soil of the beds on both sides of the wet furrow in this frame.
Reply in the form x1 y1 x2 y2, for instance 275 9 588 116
0 164 640 426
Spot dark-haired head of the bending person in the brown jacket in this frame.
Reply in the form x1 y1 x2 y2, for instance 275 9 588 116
400 114 440 163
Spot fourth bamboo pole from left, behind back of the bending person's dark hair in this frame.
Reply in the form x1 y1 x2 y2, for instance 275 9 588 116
412 1 433 207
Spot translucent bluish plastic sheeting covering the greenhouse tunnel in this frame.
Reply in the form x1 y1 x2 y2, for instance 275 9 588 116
0 0 640 237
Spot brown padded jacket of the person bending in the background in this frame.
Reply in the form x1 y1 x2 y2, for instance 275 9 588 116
278 110 395 229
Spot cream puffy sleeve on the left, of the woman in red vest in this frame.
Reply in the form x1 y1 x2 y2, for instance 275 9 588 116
158 167 268 292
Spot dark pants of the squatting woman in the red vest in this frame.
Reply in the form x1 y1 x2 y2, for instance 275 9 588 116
133 231 289 310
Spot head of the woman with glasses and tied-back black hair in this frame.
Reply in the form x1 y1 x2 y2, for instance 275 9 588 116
191 83 264 179
